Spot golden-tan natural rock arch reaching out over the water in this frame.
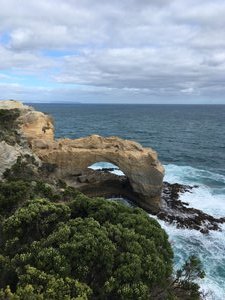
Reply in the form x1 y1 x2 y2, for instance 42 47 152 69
32 135 164 211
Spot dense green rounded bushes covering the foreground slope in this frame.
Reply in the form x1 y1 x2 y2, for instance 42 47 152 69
0 179 204 300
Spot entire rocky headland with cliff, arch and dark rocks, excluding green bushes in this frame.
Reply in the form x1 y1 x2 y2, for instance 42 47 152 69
0 100 225 233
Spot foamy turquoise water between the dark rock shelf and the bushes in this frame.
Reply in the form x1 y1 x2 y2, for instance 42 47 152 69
154 216 225 300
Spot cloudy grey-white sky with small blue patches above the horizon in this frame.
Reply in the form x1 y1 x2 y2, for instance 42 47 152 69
0 0 225 104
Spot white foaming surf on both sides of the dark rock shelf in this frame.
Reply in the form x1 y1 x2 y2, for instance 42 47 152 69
162 164 225 300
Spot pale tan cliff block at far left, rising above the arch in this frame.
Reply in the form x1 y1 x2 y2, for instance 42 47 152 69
0 100 54 179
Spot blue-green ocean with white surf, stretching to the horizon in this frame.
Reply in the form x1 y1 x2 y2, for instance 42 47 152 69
31 103 225 300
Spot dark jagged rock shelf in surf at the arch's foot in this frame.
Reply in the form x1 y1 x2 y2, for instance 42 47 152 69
157 182 225 233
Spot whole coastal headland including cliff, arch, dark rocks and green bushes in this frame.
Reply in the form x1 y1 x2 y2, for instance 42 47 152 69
0 101 212 300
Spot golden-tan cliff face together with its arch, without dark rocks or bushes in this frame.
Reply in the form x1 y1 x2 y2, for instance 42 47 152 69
0 101 164 212
